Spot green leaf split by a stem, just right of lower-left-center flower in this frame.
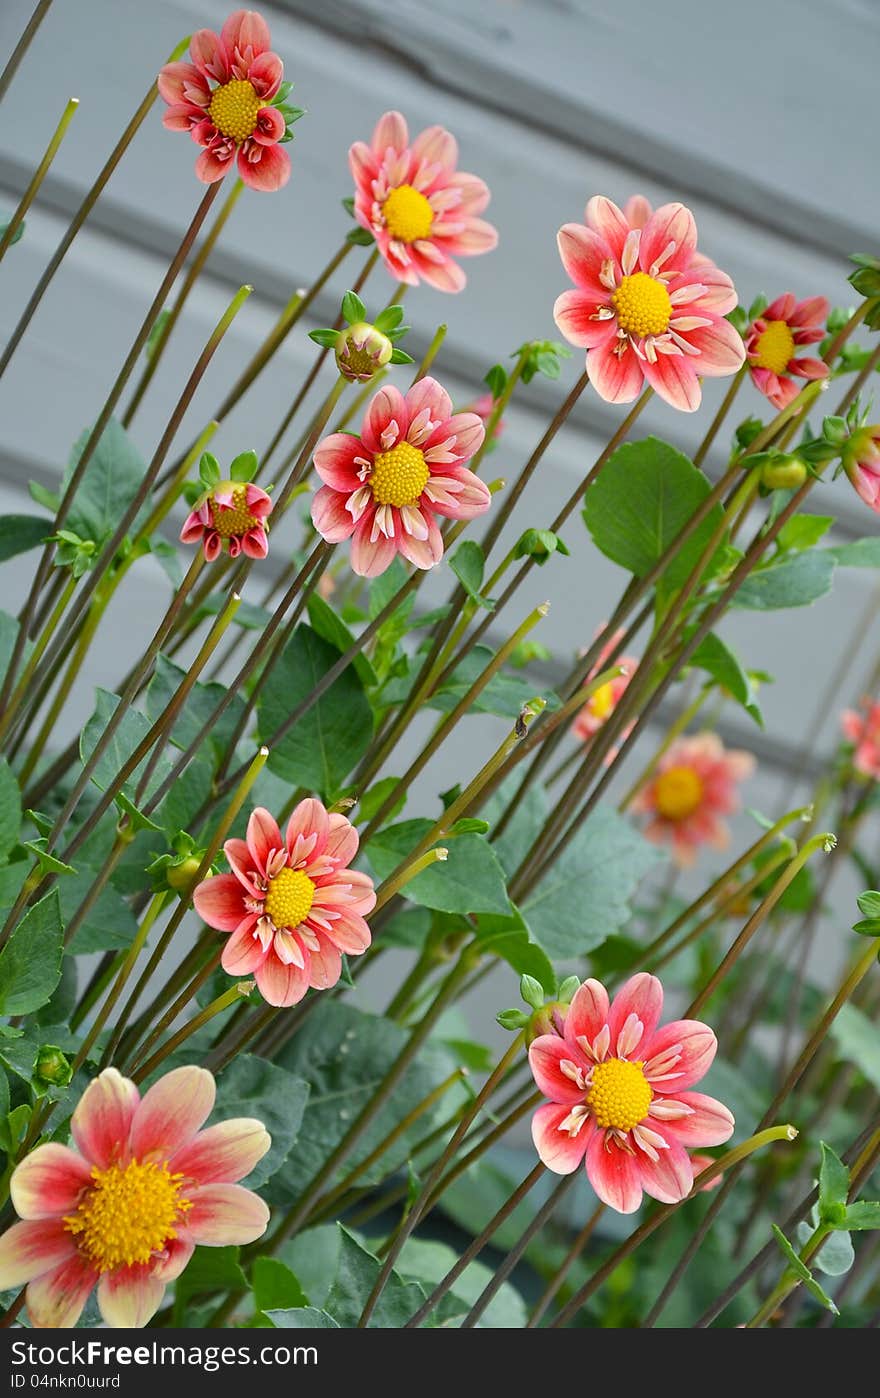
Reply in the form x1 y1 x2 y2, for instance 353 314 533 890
367 819 511 916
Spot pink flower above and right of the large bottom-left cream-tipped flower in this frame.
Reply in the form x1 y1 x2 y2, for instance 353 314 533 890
193 797 376 1005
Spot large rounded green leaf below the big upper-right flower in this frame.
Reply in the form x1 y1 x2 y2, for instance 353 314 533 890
583 438 722 587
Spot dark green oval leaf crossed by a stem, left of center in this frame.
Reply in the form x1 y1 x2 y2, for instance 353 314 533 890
257 625 374 801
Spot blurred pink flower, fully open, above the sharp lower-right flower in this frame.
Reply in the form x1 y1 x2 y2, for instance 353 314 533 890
632 733 754 868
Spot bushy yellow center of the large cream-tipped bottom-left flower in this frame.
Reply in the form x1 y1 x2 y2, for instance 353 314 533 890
64 1160 192 1272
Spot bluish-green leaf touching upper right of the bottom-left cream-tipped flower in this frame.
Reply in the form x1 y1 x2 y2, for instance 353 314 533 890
214 1054 309 1185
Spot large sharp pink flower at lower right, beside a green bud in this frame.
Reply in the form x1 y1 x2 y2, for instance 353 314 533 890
529 972 734 1213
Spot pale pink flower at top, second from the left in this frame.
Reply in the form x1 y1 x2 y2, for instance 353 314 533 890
348 112 498 291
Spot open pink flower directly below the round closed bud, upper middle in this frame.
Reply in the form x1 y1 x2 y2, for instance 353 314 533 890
312 379 491 577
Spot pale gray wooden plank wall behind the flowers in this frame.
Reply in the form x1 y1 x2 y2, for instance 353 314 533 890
0 0 880 1006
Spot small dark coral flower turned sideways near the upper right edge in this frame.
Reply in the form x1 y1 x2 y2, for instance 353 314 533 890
746 291 831 410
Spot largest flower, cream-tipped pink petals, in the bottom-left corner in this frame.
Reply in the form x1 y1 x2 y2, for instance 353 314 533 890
0 1067 271 1328
